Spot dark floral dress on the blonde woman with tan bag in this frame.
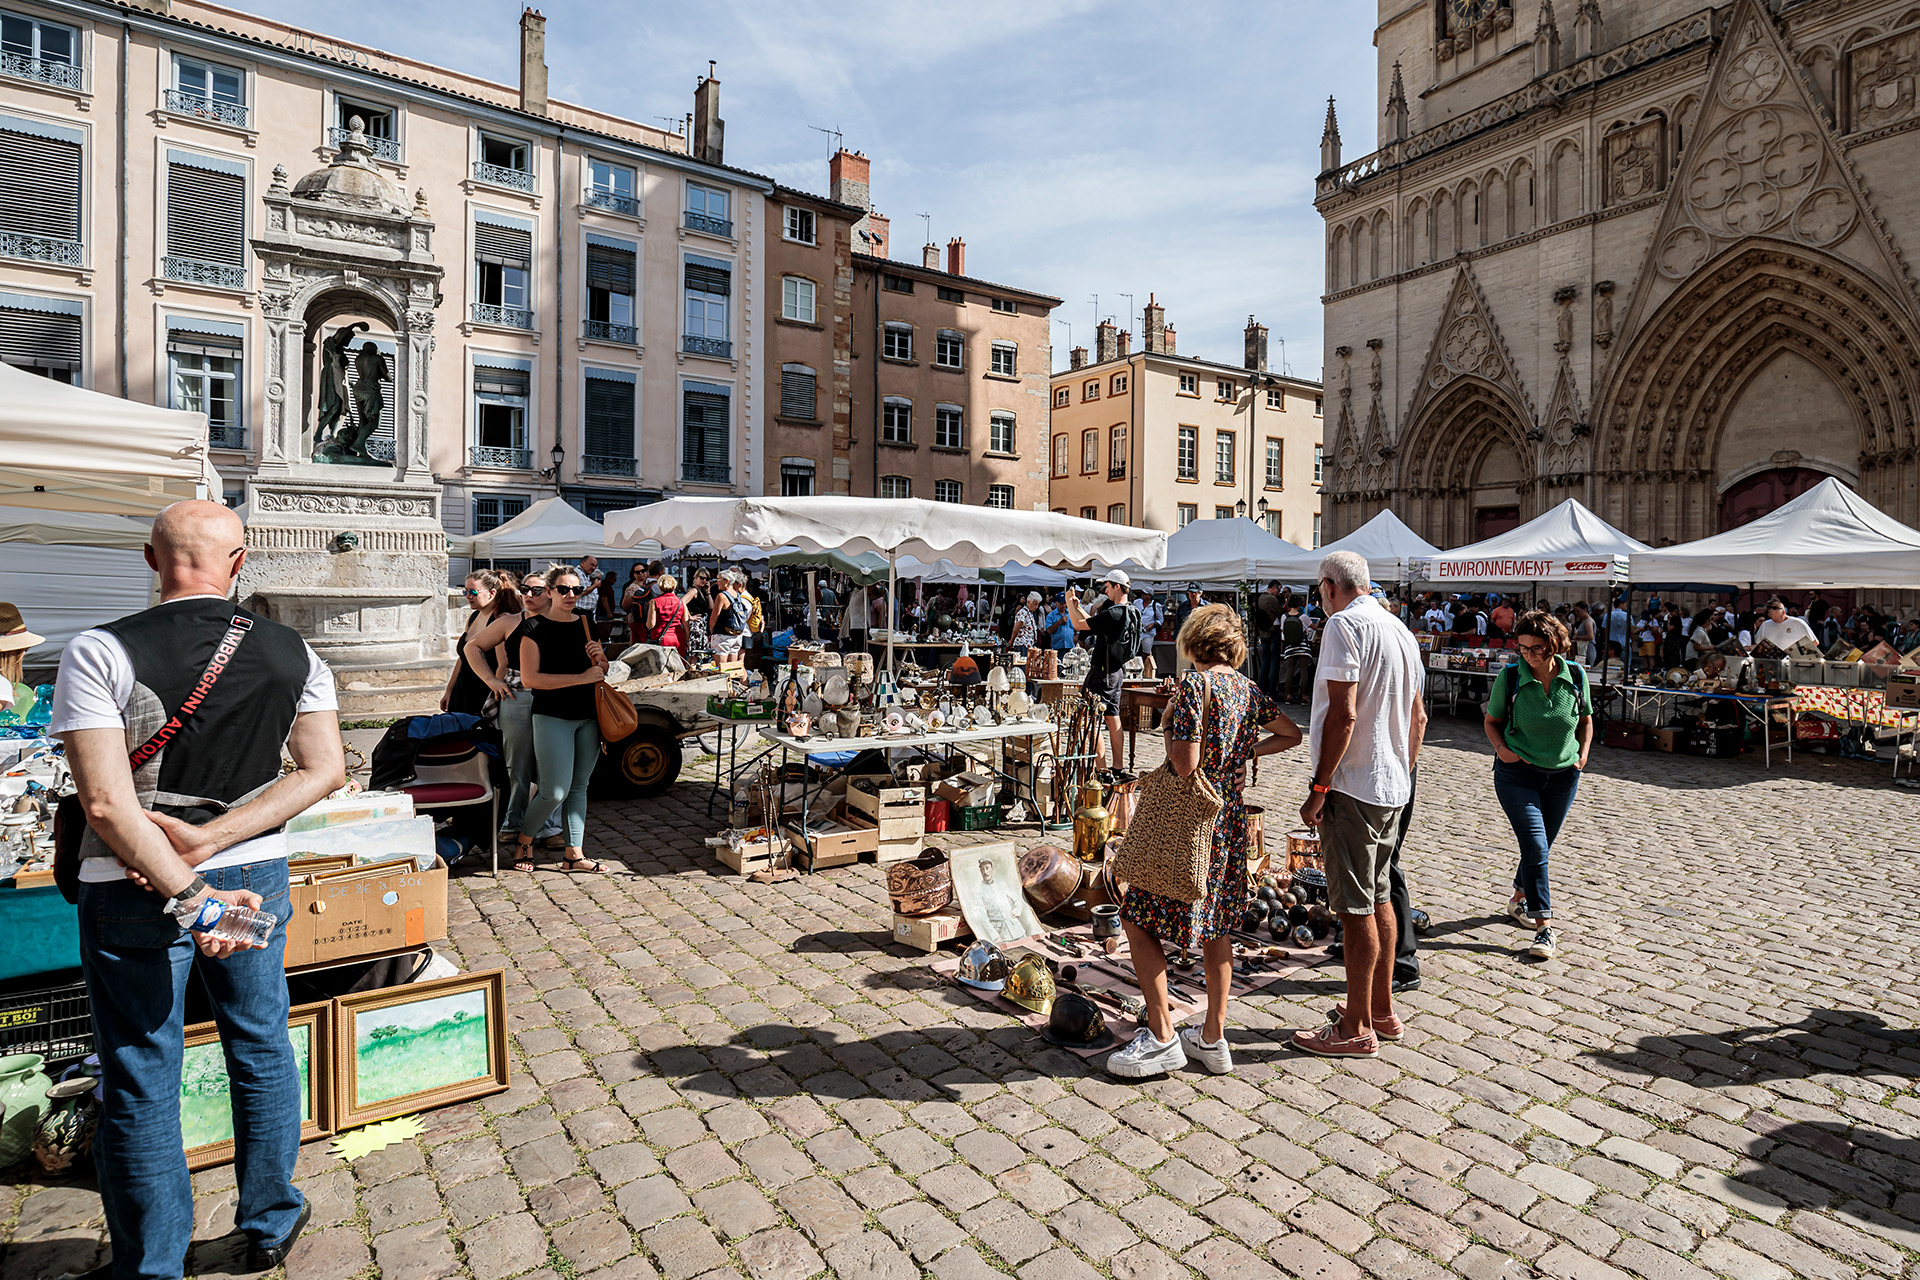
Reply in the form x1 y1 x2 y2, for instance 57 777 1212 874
1119 672 1281 950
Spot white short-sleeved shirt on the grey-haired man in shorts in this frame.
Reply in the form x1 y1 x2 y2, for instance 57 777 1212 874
1308 595 1427 808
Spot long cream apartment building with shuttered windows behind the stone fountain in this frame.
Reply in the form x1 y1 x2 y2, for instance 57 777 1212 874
0 0 780 556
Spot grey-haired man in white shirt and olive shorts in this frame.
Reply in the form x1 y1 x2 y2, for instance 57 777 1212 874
1294 551 1427 1057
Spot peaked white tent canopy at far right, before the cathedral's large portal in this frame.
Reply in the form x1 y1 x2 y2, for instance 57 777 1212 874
1628 478 1920 591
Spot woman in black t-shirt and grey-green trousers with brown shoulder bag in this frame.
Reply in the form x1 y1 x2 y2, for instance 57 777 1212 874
515 564 607 871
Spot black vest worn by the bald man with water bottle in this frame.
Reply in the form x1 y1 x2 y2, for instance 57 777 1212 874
81 599 309 858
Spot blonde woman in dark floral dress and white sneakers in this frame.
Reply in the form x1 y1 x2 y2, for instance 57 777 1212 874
1106 604 1300 1077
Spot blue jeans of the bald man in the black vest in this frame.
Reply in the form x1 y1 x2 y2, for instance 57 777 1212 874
81 862 303 1280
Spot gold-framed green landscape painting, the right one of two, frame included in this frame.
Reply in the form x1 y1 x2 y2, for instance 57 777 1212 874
334 969 511 1128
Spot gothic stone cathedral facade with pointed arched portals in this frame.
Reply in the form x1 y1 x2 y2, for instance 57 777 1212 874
1317 0 1920 547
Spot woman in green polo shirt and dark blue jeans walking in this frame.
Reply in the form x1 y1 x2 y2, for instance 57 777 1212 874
1486 608 1594 960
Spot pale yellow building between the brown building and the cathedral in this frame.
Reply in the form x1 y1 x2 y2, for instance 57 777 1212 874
1048 296 1325 547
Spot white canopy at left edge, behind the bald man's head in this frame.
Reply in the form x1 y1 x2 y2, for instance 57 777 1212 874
0 365 221 514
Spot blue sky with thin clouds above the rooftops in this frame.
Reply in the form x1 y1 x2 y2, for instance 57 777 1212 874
251 0 1375 378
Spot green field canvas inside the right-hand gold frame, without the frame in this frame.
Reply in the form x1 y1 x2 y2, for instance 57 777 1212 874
353 990 493 1107
